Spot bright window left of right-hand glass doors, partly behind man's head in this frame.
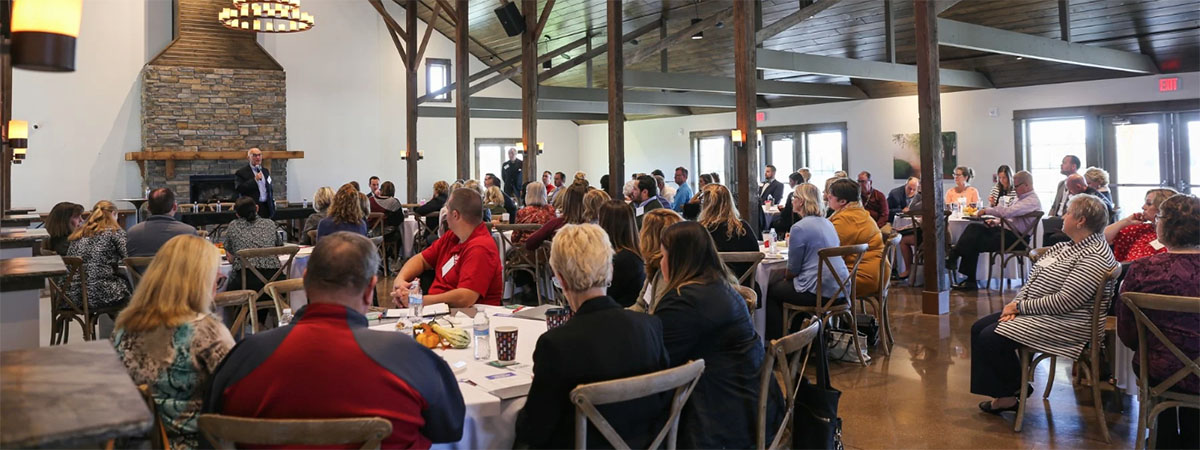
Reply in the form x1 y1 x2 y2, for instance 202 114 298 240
1022 118 1088 210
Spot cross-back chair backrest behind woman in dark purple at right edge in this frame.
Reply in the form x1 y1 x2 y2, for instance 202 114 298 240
1121 292 1200 401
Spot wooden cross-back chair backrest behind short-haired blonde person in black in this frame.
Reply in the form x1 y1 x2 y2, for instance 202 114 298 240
571 360 704 450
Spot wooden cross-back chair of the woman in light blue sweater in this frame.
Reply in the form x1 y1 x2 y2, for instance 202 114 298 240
784 244 866 366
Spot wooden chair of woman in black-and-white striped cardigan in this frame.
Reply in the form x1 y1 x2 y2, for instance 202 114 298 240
1013 266 1121 443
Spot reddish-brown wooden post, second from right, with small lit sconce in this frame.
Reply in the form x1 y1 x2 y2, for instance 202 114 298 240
733 1 760 234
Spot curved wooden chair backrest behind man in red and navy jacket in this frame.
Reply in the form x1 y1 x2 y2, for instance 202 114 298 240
197 414 391 449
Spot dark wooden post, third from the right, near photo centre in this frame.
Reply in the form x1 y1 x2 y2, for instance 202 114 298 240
604 1 625 198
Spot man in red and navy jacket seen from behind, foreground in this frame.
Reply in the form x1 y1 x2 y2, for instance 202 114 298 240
205 232 463 449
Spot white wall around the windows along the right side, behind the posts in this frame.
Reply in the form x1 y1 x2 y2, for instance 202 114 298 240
580 73 1200 192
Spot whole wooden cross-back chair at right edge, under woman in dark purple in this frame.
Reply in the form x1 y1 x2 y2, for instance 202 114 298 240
1121 292 1200 450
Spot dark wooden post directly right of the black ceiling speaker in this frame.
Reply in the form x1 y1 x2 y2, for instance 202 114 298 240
521 0 538 180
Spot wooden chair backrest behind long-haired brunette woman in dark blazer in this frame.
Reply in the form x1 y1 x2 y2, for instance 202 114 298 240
757 318 821 449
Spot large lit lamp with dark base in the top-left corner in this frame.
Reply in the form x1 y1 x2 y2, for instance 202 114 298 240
12 0 83 72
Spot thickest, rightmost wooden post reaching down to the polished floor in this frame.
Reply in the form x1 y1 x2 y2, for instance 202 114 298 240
913 0 950 314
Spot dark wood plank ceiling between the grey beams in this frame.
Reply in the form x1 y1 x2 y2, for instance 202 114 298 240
405 0 1200 119
